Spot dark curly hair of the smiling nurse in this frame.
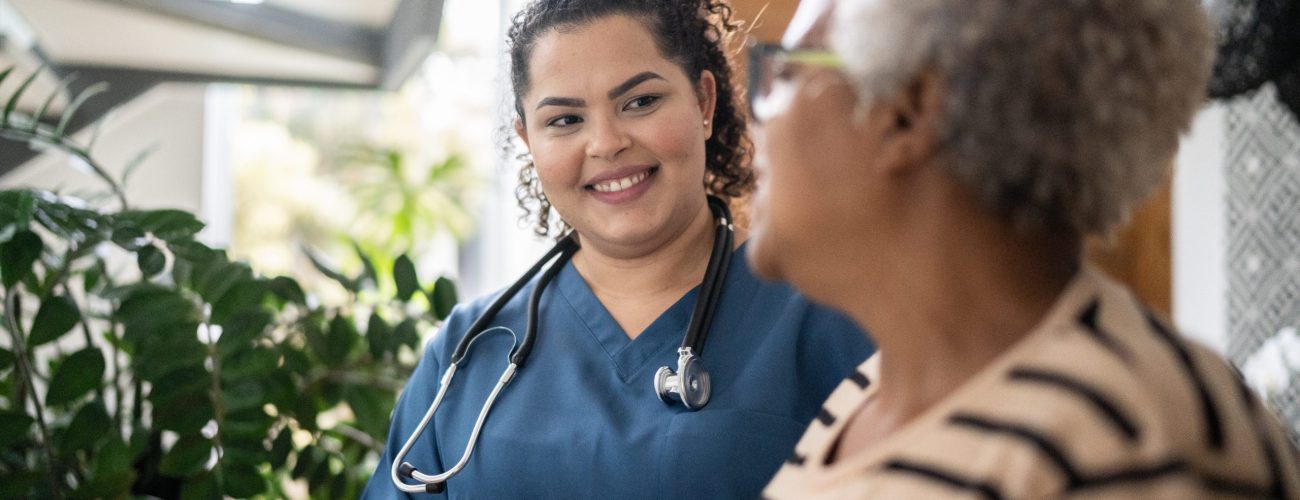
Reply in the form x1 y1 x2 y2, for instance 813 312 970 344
507 0 754 236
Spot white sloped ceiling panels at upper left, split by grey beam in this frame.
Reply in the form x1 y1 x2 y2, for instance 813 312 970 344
0 0 410 86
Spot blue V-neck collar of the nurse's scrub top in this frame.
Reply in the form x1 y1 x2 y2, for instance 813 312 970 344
555 256 707 382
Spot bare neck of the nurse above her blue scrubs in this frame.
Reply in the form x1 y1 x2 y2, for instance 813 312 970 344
573 204 714 339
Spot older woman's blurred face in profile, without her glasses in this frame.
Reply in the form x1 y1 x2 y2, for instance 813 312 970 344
749 1 878 292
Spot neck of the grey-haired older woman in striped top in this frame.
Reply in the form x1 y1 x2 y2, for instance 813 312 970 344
850 197 1080 422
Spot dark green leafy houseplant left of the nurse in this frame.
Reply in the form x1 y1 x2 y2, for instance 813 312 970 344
0 66 456 499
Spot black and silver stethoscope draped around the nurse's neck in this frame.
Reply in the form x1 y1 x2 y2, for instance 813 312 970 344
391 196 735 494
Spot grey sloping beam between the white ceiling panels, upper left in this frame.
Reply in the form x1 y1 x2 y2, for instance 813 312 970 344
91 0 384 68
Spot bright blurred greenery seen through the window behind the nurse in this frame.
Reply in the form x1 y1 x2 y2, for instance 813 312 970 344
230 64 497 303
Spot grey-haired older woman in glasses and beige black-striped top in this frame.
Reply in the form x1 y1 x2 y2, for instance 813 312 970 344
749 0 1300 499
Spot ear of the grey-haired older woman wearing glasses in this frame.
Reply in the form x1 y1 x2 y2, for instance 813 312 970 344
866 71 944 174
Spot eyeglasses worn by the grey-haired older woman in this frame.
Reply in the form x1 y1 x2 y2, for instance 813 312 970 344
749 43 844 122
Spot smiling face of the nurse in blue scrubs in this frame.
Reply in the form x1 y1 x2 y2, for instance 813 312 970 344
516 16 715 254
